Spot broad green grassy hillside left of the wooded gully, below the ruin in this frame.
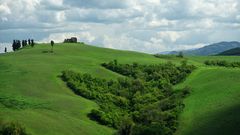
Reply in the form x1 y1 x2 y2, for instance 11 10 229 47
0 44 166 135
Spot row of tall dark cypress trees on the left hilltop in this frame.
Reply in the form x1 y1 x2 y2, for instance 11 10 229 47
12 39 35 51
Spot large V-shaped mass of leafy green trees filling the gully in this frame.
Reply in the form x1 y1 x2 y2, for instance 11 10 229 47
62 60 195 135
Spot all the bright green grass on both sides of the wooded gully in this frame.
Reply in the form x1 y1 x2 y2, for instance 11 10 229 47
0 44 240 135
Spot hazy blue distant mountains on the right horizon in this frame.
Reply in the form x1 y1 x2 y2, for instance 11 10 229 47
160 41 240 56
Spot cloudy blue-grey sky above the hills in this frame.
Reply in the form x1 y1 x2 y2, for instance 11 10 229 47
0 0 240 53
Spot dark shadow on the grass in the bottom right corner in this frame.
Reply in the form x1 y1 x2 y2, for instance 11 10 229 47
185 105 240 135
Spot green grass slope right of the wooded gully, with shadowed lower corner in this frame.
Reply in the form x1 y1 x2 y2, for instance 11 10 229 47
176 68 240 135
